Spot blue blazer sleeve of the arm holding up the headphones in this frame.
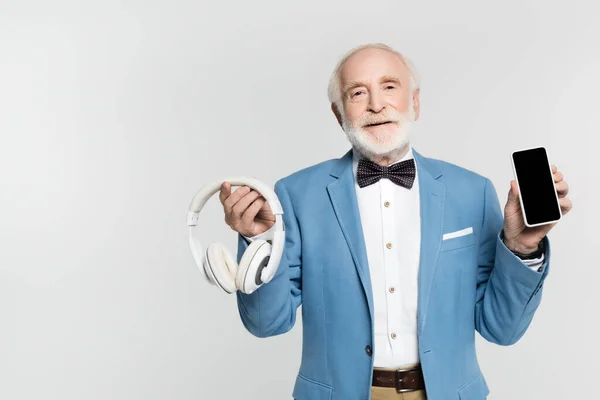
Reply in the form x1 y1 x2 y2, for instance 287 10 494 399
236 180 302 338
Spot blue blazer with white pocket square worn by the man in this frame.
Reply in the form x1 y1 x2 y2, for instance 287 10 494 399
236 148 550 400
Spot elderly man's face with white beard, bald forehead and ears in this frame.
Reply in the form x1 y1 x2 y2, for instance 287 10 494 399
332 48 419 163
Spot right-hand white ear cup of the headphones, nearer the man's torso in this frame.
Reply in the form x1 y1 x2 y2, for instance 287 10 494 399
235 239 272 293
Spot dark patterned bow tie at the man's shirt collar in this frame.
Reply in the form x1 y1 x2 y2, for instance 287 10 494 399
356 158 416 189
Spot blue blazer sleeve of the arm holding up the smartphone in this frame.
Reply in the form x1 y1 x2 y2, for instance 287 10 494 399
475 178 550 346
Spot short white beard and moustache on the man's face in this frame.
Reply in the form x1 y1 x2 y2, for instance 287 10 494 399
342 97 415 159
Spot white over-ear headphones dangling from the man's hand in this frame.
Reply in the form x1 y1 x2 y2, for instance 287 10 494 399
187 176 285 294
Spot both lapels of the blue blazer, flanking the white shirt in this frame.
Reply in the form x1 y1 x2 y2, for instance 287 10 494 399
327 147 446 335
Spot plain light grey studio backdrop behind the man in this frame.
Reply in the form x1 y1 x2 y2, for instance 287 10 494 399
0 0 600 400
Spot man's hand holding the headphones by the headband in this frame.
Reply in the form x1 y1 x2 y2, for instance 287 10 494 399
219 182 275 237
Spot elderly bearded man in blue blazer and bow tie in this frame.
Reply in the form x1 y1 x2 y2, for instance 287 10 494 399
220 44 572 400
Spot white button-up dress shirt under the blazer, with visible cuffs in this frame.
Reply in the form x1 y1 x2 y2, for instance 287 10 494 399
244 143 543 368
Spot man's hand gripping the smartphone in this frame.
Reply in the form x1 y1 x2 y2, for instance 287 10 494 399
504 165 573 254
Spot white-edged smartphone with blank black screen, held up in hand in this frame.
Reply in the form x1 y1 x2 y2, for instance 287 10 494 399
511 146 562 227
